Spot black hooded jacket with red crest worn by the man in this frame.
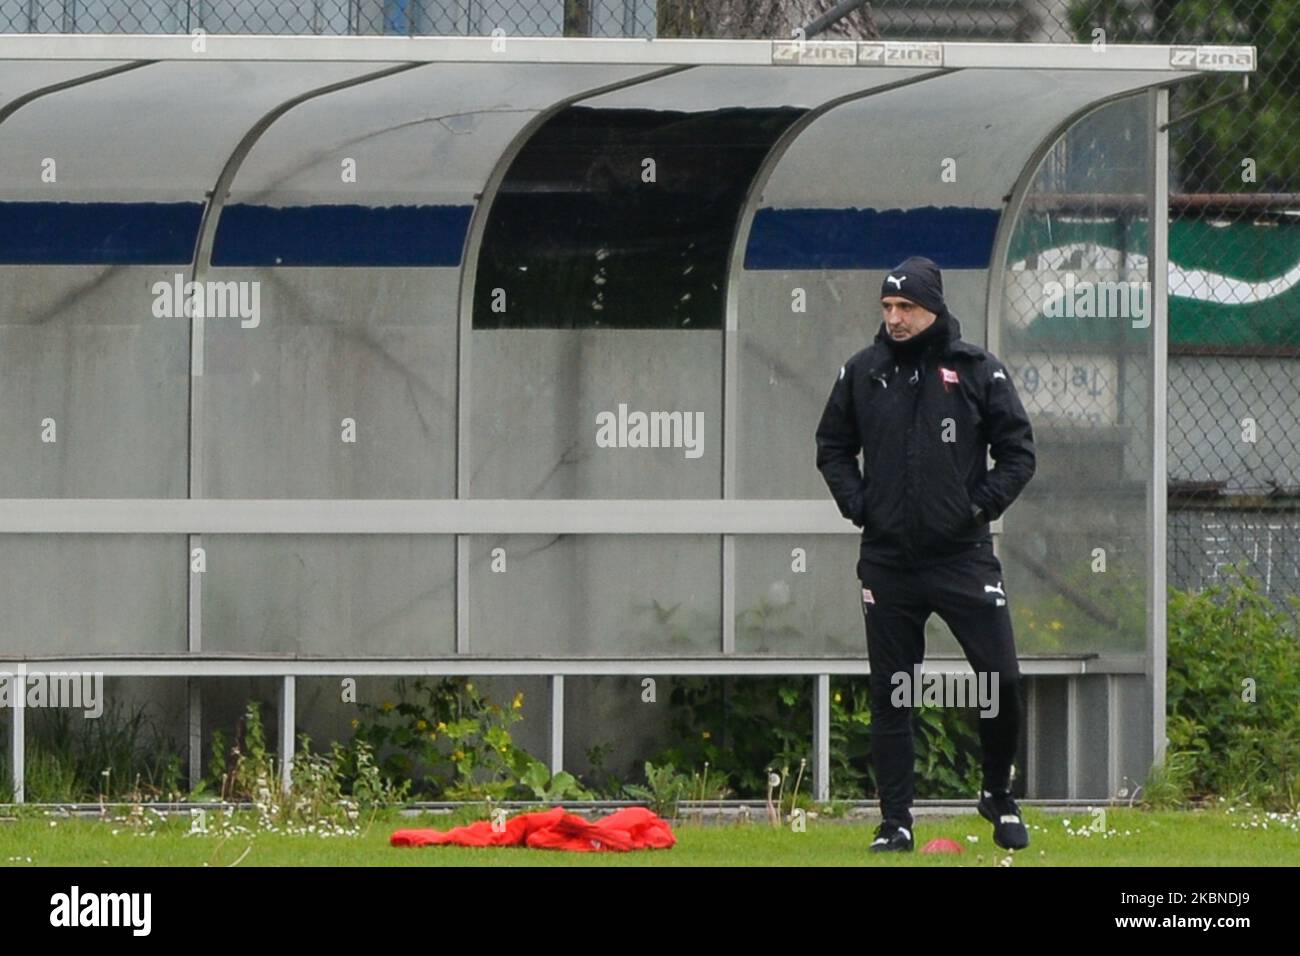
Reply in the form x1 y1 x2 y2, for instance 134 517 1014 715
816 310 1035 566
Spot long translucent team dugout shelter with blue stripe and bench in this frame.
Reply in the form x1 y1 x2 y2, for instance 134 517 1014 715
0 35 1255 800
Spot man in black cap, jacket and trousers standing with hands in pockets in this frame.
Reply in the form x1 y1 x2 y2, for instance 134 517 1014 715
816 256 1035 852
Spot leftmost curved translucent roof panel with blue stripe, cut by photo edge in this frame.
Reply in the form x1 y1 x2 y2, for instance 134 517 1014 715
0 62 380 264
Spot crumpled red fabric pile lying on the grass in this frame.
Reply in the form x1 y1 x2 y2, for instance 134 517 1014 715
389 806 677 853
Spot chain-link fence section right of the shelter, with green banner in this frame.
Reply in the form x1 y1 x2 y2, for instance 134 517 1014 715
1061 0 1300 606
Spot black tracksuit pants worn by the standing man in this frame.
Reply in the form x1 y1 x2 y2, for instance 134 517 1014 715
858 542 1024 827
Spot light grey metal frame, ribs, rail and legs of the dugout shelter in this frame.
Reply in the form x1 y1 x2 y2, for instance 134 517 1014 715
0 35 1255 801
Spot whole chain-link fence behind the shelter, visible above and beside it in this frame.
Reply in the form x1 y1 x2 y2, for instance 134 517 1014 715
10 0 1300 613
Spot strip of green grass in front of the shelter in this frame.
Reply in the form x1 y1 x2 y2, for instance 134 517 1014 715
0 808 1300 866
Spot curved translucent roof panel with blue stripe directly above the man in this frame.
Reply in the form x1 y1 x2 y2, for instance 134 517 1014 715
745 69 1185 269
